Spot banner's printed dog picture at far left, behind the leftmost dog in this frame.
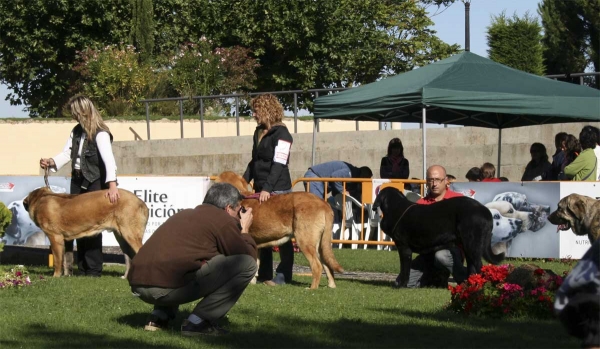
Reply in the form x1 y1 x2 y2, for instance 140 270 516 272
0 176 70 246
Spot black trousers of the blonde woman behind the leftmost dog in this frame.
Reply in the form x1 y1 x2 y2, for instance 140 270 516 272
65 172 108 276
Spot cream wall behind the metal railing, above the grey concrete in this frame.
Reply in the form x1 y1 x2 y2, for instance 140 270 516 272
0 118 379 175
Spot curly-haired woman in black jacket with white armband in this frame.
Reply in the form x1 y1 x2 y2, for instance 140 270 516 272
244 94 294 286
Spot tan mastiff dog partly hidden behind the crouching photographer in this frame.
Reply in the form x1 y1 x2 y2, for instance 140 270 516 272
215 171 344 289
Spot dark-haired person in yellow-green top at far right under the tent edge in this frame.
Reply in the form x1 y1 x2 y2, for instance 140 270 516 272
564 127 598 181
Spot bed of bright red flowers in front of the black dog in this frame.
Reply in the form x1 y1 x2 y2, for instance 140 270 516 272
448 264 563 318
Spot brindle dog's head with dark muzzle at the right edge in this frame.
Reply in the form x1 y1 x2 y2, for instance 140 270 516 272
548 194 600 243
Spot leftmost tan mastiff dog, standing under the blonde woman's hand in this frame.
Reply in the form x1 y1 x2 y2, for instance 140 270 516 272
23 187 148 277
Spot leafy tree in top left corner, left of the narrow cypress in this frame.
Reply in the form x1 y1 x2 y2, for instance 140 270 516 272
0 0 130 117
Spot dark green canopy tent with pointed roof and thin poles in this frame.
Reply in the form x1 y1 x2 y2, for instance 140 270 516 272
313 52 600 178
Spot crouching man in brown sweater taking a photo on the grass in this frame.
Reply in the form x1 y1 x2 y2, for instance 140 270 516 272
128 183 257 336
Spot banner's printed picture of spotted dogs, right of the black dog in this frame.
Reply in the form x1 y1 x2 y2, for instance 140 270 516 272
451 182 560 258
